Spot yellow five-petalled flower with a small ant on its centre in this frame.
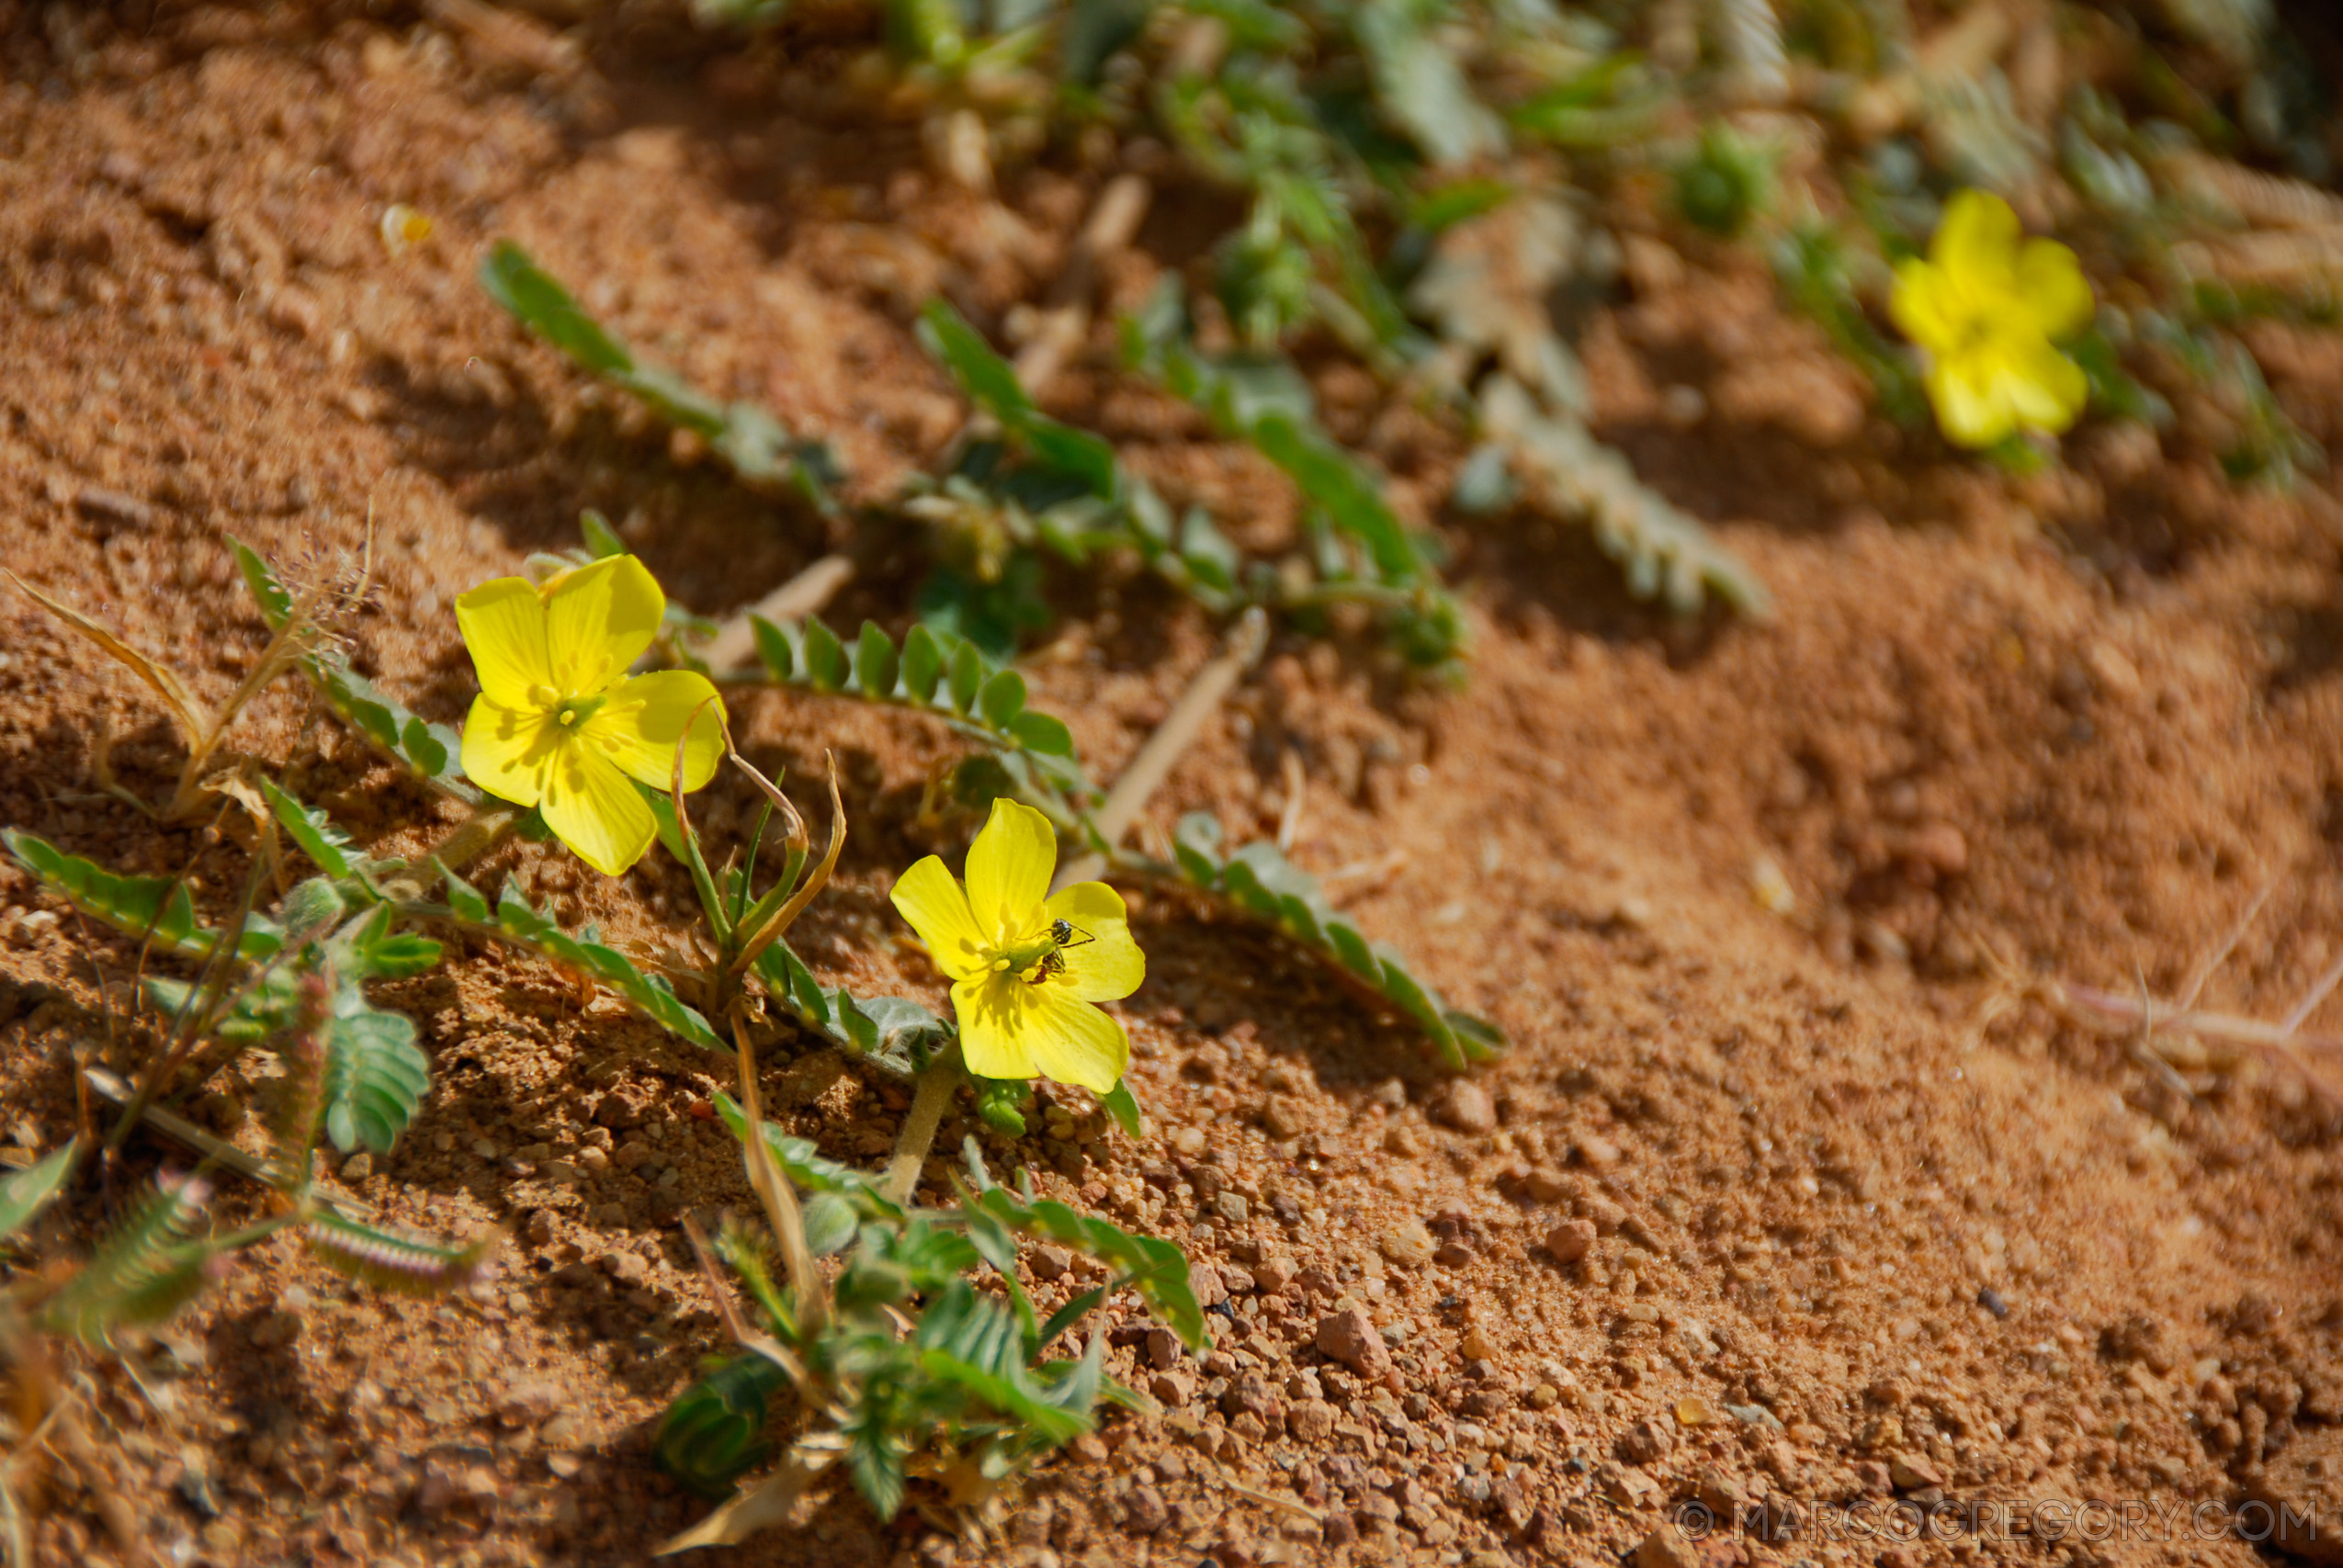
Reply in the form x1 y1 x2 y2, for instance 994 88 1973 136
893 799 1149 1095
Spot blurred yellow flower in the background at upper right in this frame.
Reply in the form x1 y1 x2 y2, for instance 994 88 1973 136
1888 190 2092 447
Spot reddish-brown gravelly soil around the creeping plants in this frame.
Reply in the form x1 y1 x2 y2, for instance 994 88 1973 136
0 3 2343 1568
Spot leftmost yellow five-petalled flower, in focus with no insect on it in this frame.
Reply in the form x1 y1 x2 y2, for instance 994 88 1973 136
455 556 724 876
